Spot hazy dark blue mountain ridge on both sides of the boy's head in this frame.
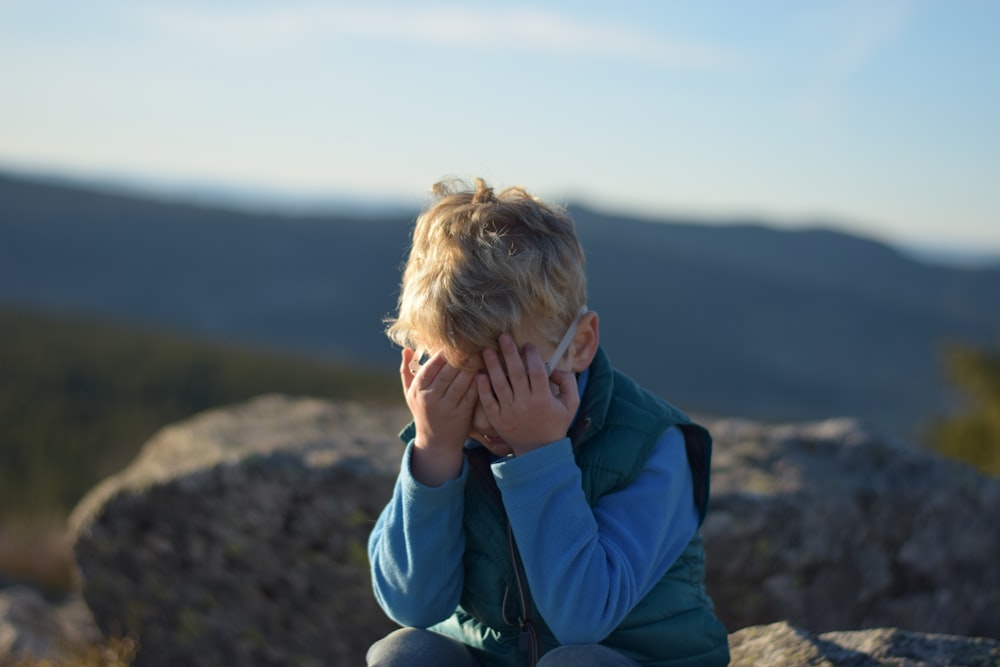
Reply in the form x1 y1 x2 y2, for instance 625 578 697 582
0 174 1000 435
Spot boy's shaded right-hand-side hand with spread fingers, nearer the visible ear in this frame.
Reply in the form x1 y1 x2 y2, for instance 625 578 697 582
477 334 580 455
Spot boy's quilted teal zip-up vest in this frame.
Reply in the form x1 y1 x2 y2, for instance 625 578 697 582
433 350 729 667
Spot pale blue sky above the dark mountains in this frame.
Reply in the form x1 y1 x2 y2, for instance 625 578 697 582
0 0 1000 255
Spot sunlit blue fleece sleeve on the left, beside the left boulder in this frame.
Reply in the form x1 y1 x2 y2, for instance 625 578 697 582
368 442 468 628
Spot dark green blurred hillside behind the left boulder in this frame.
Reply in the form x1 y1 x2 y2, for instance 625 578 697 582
0 309 399 520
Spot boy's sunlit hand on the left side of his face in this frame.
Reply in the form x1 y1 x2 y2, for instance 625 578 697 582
400 349 478 453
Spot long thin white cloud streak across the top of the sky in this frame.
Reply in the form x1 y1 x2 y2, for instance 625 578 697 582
144 5 739 69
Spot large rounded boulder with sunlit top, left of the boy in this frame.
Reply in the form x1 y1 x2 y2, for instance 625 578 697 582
70 396 406 666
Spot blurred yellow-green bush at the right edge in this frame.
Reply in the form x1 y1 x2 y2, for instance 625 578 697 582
930 347 1000 477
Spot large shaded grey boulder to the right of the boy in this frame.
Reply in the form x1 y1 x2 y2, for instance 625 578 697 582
704 420 1000 637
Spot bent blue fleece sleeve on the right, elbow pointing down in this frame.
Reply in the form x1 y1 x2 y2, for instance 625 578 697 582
493 428 698 644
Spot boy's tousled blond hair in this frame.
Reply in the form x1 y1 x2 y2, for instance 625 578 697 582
386 178 587 365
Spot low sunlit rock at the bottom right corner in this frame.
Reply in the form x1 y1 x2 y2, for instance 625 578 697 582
729 621 1000 667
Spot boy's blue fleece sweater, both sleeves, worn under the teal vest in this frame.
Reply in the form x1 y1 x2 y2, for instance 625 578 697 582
368 372 698 644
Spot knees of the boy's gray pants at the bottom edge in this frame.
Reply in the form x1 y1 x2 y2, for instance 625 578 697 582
368 628 641 667
